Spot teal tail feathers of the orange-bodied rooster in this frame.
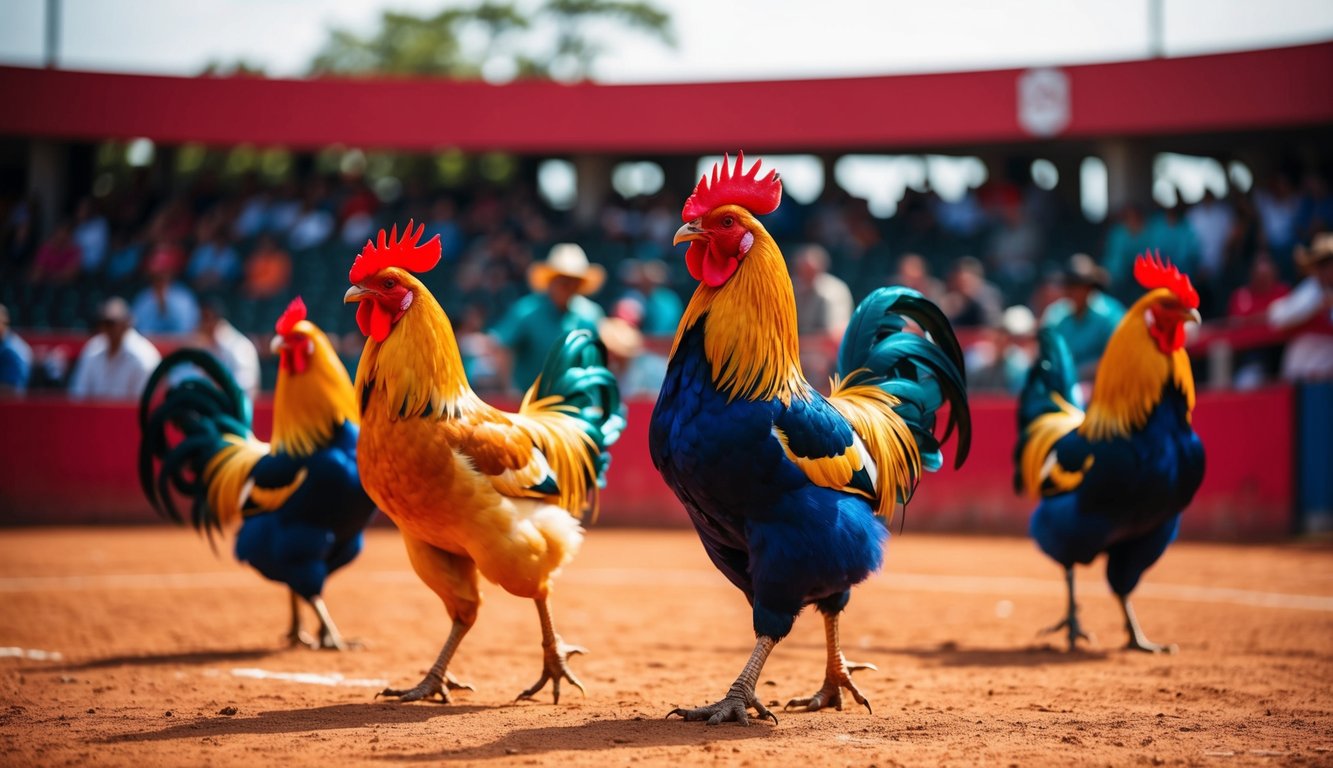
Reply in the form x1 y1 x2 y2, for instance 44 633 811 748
536 331 625 487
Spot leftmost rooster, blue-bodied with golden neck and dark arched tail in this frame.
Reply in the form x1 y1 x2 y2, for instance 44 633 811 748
139 297 375 651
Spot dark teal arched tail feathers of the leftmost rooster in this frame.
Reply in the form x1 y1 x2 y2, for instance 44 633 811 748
139 349 252 533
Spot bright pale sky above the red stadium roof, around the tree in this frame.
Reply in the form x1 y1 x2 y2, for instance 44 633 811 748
0 0 1333 83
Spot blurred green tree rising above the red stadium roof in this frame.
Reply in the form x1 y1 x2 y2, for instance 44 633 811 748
311 0 674 80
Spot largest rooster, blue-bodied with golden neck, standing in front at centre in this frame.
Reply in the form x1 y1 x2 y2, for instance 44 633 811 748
649 155 970 724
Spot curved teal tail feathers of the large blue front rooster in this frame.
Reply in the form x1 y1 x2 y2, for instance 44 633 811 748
837 287 972 471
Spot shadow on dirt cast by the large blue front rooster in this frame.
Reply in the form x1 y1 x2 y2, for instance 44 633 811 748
379 715 781 764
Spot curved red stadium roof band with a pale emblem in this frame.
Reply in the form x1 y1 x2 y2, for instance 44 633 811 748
0 43 1333 155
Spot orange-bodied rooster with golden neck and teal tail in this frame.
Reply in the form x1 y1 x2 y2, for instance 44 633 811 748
345 223 624 704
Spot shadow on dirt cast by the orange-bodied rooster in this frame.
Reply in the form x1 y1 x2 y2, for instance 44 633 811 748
101 701 491 744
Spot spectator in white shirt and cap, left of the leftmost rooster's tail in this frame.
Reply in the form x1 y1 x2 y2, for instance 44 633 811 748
69 296 161 400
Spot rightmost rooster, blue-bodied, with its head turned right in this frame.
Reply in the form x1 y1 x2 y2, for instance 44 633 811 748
1014 255 1204 653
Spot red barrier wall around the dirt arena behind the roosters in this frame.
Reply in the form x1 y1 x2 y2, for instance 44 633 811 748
0 387 1294 540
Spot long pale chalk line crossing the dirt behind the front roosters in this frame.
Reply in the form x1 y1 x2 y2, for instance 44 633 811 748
0 568 1333 613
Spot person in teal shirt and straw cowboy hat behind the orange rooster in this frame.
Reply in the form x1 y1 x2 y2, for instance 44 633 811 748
491 243 607 392
